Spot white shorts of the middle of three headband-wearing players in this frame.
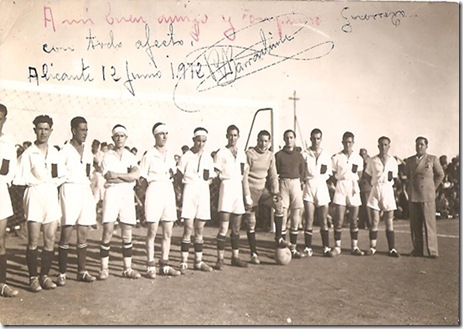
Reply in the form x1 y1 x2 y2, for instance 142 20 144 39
145 181 177 223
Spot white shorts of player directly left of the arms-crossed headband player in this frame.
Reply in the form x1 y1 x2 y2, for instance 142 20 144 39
59 183 96 226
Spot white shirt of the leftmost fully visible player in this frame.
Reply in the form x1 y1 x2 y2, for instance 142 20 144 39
13 144 63 186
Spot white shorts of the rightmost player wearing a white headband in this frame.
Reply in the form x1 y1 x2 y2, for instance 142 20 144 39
182 182 211 220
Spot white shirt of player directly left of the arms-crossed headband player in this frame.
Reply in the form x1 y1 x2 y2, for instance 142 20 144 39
59 142 93 184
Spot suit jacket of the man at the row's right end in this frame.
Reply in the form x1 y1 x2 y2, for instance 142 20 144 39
407 154 444 202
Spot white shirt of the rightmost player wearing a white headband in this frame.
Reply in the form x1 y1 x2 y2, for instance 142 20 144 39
177 150 215 184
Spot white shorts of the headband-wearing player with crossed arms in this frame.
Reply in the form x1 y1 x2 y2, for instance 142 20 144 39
103 183 137 225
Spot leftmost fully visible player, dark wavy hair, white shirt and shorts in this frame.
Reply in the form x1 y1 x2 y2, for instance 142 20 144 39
14 115 62 292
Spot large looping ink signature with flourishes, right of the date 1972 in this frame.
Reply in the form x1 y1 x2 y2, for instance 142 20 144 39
173 13 334 112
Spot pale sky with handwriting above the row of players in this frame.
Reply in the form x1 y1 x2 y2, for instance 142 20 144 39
0 0 460 158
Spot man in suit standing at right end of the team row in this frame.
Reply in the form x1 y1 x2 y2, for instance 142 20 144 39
407 136 444 258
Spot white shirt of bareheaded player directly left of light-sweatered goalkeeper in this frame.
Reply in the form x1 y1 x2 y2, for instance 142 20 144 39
214 147 247 180
